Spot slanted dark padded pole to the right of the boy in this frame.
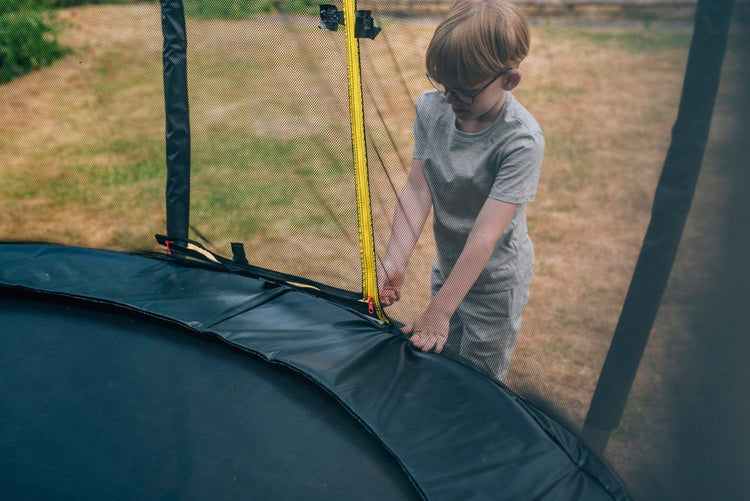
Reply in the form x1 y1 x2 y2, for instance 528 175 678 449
582 0 734 453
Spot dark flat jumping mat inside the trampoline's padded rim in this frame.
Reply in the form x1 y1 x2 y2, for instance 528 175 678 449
0 291 419 500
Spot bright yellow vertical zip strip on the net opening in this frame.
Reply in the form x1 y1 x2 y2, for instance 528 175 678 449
344 0 388 322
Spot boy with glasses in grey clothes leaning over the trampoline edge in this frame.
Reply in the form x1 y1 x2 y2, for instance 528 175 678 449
379 0 544 381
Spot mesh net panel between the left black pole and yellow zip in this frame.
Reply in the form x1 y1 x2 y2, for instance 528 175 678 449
187 4 361 290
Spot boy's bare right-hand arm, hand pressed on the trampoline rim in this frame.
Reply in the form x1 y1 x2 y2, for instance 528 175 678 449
403 198 516 353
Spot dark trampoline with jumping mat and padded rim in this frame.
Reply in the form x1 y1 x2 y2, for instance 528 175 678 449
0 244 627 500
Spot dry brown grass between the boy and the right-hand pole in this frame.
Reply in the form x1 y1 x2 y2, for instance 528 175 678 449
510 27 685 422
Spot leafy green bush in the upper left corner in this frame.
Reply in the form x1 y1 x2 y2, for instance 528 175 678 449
0 0 65 84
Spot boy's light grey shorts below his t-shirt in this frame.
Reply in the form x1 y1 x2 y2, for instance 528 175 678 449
432 268 529 381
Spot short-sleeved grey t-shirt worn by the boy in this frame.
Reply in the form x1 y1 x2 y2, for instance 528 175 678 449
413 90 545 292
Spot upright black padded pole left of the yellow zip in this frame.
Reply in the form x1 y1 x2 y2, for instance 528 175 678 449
160 0 190 246
